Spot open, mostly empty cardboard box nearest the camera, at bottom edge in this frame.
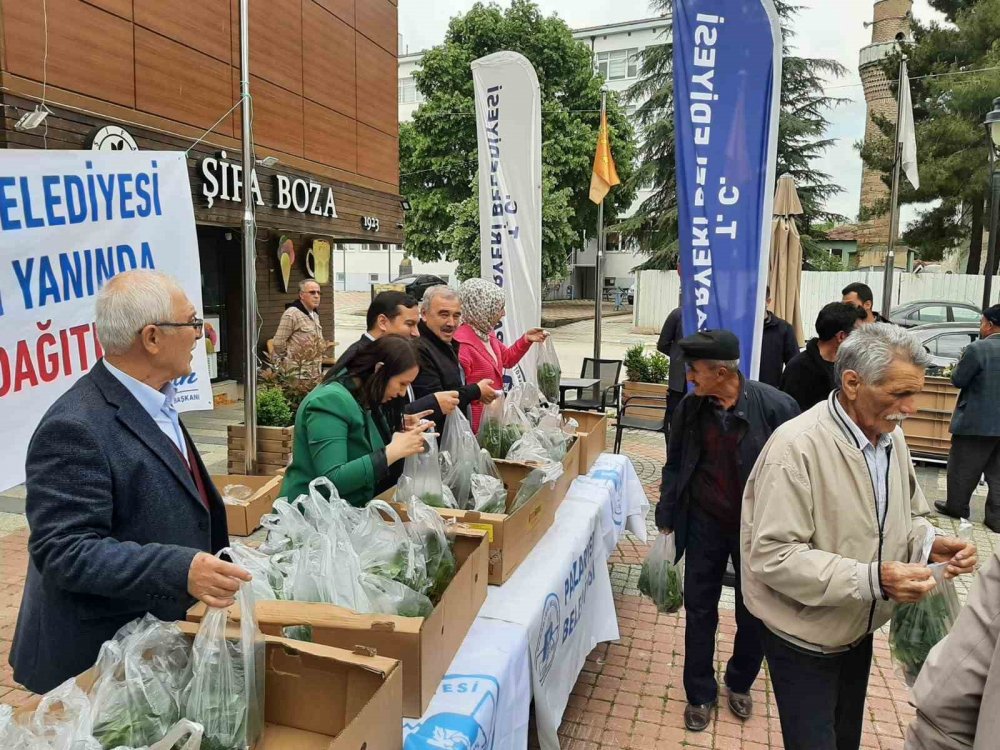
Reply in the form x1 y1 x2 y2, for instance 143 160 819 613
18 622 403 750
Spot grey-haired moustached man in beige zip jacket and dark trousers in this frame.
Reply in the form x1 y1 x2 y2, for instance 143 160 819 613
740 323 976 750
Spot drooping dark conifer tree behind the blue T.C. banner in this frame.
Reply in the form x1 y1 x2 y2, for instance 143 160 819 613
619 0 846 269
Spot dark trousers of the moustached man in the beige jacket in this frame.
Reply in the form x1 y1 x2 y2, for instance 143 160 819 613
761 626 872 750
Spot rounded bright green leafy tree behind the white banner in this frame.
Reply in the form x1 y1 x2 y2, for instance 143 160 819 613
400 0 635 279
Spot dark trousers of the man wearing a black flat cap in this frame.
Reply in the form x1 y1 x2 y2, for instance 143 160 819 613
684 509 764 704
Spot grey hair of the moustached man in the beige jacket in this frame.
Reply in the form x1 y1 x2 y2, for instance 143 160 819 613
836 323 931 385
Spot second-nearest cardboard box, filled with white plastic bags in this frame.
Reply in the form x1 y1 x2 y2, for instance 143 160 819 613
188 529 489 720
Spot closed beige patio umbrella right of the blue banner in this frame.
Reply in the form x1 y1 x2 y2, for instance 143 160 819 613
767 174 805 346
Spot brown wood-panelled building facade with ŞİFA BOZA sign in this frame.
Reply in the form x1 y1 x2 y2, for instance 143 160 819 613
0 0 403 377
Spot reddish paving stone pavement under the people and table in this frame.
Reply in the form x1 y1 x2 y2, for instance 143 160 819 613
0 424 998 750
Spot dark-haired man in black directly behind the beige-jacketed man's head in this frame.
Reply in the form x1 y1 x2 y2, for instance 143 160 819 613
781 302 865 411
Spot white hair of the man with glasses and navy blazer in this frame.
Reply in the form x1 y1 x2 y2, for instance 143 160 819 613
95 270 183 355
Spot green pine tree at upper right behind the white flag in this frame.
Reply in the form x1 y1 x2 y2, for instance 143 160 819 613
861 0 1000 273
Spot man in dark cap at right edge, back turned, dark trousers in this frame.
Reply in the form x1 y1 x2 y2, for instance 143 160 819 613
934 305 1000 533
